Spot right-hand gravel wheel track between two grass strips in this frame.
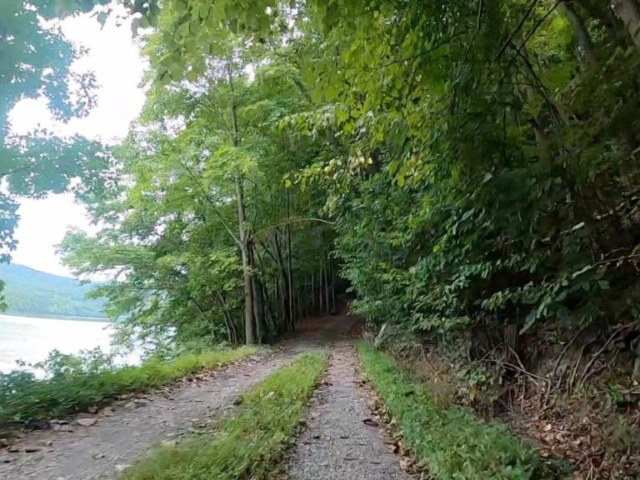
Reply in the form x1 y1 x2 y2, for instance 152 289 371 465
289 340 410 480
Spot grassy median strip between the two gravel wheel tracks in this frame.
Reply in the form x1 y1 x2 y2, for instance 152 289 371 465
124 353 327 480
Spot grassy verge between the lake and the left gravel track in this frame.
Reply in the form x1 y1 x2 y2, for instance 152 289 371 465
0 347 257 430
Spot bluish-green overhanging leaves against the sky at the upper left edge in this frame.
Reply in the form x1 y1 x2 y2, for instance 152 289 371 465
0 0 112 300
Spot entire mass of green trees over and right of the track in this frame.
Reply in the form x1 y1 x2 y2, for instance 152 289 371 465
50 0 640 364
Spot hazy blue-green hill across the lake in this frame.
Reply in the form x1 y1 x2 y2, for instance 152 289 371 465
0 264 105 318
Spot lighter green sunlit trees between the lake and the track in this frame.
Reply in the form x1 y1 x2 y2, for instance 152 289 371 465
60 17 335 344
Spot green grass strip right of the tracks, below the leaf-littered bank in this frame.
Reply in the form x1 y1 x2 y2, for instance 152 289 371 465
358 344 549 480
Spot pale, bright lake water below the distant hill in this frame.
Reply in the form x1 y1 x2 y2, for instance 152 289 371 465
0 315 112 373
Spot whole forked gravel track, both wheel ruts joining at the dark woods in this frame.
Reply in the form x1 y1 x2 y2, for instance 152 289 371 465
0 315 404 480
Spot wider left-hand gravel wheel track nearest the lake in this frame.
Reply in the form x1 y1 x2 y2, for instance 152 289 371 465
0 345 300 480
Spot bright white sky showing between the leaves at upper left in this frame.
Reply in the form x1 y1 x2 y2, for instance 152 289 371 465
9 12 144 276
